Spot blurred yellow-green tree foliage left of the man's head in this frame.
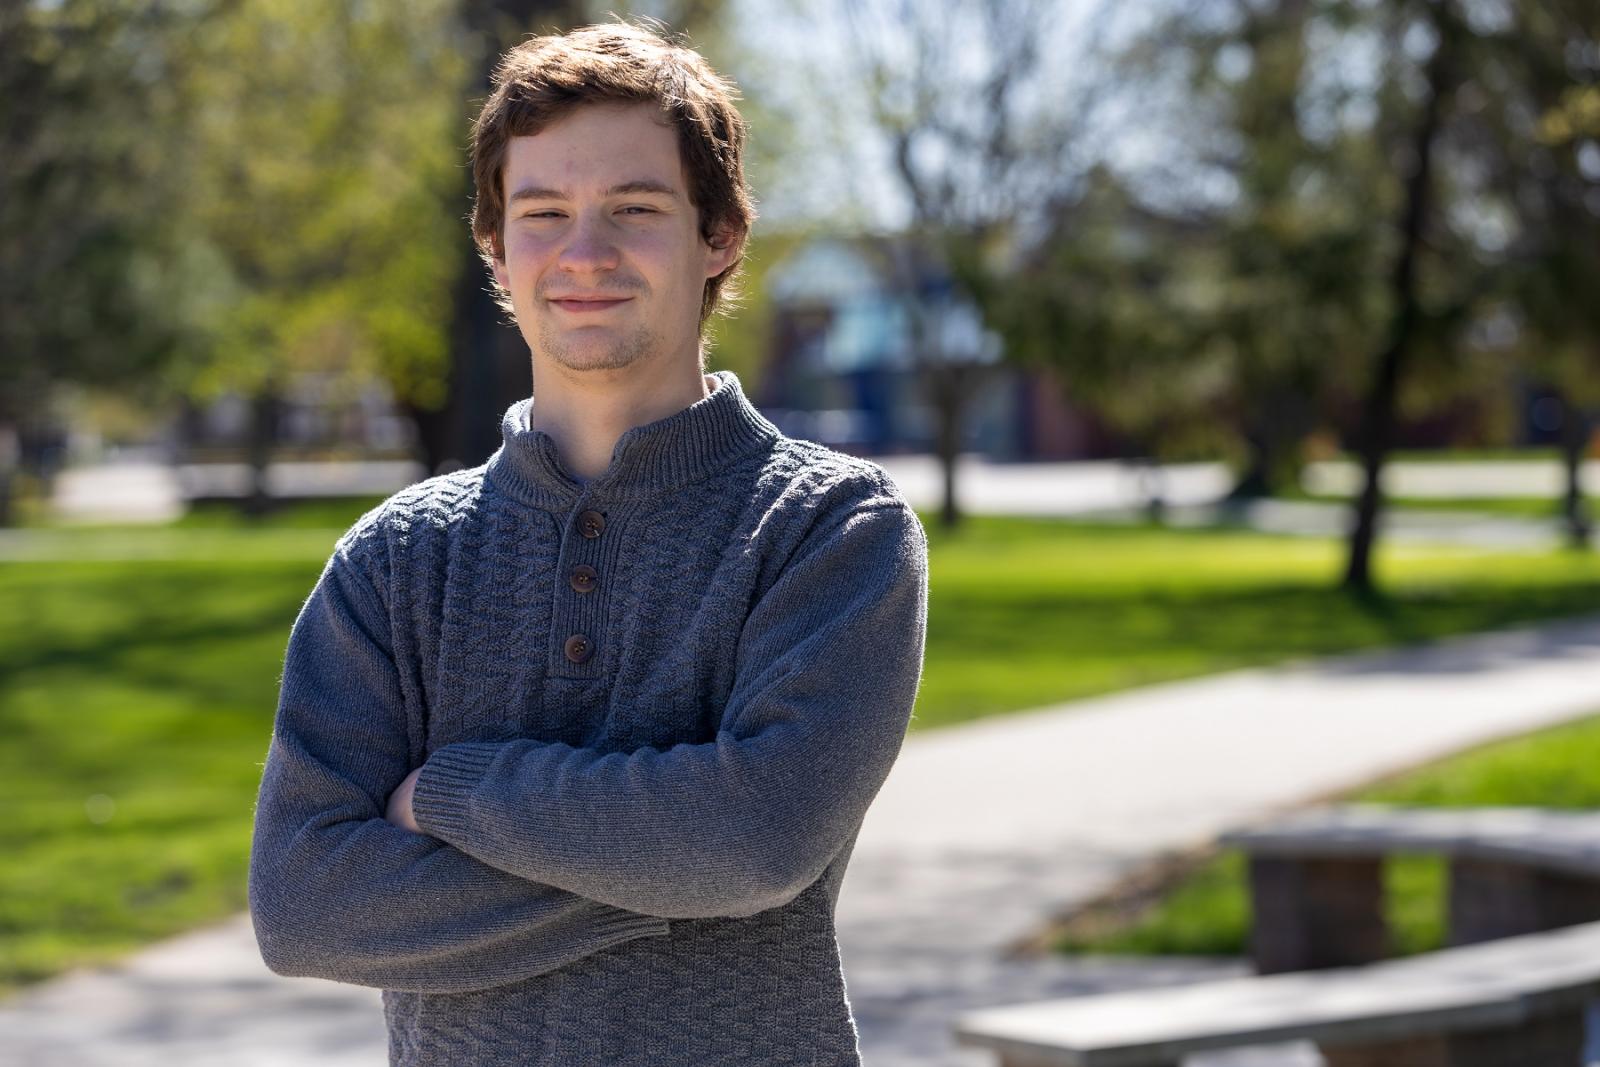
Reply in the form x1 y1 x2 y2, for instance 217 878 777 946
0 0 470 421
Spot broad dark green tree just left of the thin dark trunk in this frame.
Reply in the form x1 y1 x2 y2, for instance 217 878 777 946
1005 0 1381 498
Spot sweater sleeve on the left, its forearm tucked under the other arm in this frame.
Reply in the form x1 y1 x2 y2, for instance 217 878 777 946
250 549 667 992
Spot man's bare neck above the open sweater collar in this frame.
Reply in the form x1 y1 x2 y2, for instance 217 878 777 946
528 351 714 482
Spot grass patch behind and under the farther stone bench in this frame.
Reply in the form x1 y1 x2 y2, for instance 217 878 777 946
1054 717 1600 955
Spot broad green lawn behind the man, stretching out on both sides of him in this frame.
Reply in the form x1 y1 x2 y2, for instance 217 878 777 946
9 501 1600 989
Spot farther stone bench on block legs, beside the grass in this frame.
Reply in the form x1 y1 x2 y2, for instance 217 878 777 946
1222 805 1600 974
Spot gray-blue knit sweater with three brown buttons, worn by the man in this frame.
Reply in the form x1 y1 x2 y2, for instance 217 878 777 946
250 373 926 1067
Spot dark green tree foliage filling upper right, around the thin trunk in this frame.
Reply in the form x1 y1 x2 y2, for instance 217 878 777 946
987 0 1600 494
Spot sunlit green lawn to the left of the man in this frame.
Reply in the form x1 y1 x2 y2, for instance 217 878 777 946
0 556 326 987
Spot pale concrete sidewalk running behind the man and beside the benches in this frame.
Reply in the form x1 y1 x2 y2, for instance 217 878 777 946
0 616 1600 1067
